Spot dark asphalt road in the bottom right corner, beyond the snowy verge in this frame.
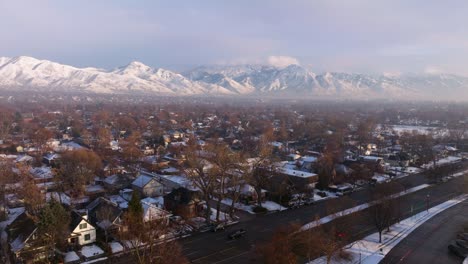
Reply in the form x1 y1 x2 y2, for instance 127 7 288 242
381 200 468 264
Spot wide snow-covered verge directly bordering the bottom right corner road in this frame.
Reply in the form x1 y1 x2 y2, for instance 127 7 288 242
309 195 468 264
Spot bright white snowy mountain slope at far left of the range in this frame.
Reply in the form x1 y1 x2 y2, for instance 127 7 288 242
0 56 214 95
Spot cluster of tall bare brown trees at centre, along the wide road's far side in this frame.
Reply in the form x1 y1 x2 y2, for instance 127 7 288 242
181 138 275 222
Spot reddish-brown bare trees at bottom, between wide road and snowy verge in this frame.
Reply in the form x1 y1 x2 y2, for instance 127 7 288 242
253 182 403 264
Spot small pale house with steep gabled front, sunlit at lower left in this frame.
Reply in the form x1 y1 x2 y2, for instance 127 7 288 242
68 211 96 246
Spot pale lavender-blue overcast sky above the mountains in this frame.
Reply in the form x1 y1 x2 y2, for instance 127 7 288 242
0 0 468 75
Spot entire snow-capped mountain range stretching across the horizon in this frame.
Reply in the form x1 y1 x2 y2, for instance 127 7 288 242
0 56 468 99
